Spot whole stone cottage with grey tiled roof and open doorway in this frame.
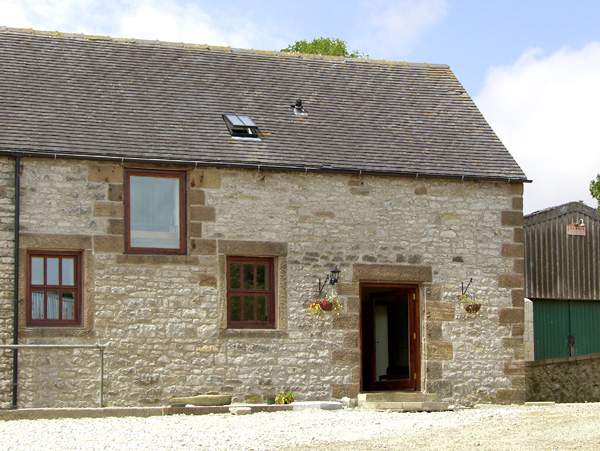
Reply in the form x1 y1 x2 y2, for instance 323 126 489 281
0 28 527 407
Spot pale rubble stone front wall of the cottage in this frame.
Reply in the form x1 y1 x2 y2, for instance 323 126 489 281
0 159 525 407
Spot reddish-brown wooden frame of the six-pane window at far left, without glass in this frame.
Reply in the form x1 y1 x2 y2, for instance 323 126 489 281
26 250 83 327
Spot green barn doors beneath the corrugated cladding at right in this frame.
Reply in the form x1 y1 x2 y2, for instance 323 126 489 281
533 300 600 360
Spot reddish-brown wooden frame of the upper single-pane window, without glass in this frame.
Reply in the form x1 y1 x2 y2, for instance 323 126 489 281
124 169 187 254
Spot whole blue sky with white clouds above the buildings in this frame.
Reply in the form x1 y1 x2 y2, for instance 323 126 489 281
0 0 600 214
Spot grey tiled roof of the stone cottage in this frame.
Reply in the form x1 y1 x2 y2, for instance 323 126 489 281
0 28 526 181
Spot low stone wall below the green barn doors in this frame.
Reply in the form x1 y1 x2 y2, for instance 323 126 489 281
526 354 600 402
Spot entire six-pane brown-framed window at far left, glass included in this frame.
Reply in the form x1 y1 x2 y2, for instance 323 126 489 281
27 251 83 326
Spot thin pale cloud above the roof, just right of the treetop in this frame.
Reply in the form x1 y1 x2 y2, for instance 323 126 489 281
356 0 448 58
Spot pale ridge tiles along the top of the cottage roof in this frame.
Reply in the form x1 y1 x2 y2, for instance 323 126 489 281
0 26 450 69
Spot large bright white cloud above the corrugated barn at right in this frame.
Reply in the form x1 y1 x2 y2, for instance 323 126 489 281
475 42 600 214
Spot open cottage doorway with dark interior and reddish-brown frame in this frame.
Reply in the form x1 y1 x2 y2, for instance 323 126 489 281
361 286 420 391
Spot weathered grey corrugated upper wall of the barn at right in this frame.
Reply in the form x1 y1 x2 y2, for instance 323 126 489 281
524 202 600 300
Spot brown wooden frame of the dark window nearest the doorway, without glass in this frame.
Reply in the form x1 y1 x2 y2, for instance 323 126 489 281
227 257 276 329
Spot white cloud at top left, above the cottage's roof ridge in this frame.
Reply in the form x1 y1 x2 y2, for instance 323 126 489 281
0 0 286 49
